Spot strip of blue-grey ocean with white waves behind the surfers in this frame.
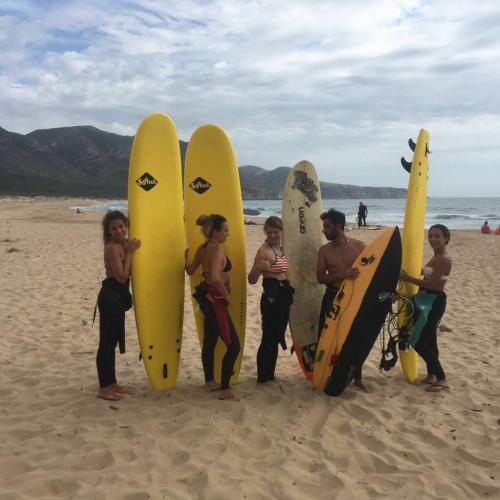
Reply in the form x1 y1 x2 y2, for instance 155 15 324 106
68 198 500 229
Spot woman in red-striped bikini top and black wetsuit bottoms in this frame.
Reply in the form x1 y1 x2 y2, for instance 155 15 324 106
248 216 295 384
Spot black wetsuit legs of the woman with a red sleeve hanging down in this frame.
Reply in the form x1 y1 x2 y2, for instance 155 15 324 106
201 300 241 389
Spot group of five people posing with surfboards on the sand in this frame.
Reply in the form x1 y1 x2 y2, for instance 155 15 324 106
96 209 451 401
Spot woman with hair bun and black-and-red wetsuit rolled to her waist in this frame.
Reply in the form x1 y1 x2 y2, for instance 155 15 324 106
185 214 240 400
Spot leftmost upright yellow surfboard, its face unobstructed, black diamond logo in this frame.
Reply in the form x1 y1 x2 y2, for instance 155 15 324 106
128 113 185 390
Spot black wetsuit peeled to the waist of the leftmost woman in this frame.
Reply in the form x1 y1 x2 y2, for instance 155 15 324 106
96 277 132 388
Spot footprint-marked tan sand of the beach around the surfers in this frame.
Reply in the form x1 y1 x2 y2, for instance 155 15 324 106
0 198 500 500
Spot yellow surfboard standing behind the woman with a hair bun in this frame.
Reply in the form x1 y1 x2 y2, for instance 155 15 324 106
184 125 247 384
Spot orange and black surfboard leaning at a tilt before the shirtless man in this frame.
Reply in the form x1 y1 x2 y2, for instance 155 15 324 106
313 227 401 395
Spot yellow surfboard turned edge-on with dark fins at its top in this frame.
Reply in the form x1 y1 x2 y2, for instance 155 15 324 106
398 129 429 382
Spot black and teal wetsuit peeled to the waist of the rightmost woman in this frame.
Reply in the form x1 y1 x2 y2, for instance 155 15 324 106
413 288 446 380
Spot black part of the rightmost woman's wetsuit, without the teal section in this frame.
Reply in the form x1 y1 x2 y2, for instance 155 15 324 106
415 290 446 380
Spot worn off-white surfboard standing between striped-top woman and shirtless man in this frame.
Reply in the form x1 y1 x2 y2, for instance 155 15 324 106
282 161 325 379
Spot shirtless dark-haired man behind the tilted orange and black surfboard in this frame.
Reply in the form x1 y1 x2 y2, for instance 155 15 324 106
316 208 368 392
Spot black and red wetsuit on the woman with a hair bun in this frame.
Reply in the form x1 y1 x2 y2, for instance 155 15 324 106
193 257 241 389
